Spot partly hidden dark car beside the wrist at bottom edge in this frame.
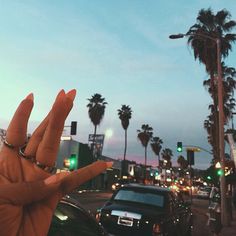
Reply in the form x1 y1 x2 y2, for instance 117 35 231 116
48 197 108 236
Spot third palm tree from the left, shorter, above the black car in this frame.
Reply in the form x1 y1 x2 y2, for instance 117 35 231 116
137 124 153 178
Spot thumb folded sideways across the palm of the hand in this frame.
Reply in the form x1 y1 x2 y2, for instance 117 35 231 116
0 181 59 205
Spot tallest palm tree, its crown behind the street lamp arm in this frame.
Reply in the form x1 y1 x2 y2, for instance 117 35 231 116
187 8 236 162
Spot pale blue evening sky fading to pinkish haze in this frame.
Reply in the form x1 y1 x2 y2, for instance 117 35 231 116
0 0 236 169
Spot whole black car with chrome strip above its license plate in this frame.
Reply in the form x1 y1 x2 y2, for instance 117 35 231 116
97 184 192 236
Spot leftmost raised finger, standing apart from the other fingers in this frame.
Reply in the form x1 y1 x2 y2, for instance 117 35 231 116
6 93 34 147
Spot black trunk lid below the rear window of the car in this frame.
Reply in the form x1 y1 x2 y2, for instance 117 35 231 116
102 202 166 219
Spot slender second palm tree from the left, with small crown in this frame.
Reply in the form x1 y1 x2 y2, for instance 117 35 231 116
117 105 132 174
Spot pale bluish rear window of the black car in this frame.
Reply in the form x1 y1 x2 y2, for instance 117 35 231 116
114 189 164 207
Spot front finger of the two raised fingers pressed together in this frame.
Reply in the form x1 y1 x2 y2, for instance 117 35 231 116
36 90 76 166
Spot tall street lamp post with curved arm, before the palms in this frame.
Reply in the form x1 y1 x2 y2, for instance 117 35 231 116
169 33 229 225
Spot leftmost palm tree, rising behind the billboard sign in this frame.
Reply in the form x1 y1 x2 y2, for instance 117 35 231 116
87 93 107 159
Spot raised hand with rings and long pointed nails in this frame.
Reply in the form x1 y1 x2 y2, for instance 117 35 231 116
0 90 112 236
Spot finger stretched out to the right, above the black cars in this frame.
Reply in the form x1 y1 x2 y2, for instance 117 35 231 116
54 161 113 196
